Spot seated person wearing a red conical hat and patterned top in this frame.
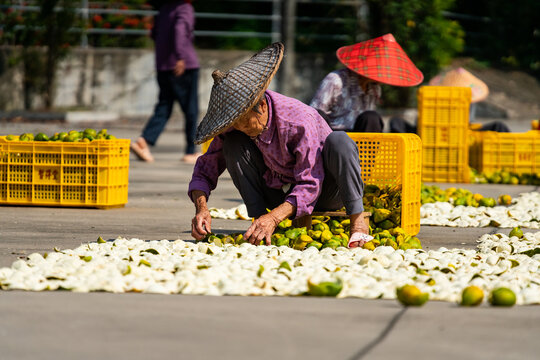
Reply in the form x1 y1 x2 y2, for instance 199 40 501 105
310 34 424 132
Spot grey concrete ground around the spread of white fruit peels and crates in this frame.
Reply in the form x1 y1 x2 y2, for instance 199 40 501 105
0 123 540 360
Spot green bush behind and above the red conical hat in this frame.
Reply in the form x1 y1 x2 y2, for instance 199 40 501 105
368 0 465 106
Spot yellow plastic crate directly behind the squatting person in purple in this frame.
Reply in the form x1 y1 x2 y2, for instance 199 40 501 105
348 133 422 235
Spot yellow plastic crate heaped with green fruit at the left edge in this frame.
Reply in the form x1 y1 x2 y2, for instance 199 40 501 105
0 136 130 208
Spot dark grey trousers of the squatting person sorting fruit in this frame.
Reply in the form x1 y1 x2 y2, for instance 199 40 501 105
223 131 364 218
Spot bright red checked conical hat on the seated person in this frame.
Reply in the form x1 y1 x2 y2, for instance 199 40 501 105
336 34 424 86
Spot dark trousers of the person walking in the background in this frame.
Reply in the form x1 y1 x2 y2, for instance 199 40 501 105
141 69 199 154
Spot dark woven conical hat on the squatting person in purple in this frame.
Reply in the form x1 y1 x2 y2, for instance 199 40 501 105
195 42 284 144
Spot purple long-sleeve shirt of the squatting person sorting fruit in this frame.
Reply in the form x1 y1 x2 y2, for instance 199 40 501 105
188 90 332 217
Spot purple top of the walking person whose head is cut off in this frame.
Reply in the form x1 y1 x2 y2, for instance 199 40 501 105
152 0 199 71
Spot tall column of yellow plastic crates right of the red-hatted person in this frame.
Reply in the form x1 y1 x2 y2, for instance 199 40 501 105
418 86 471 183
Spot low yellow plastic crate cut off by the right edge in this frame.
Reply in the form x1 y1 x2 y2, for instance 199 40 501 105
470 130 540 174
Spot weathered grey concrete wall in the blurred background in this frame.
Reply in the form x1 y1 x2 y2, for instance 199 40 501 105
0 49 337 116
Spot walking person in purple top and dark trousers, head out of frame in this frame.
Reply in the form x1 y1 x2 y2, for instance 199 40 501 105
131 0 200 164
